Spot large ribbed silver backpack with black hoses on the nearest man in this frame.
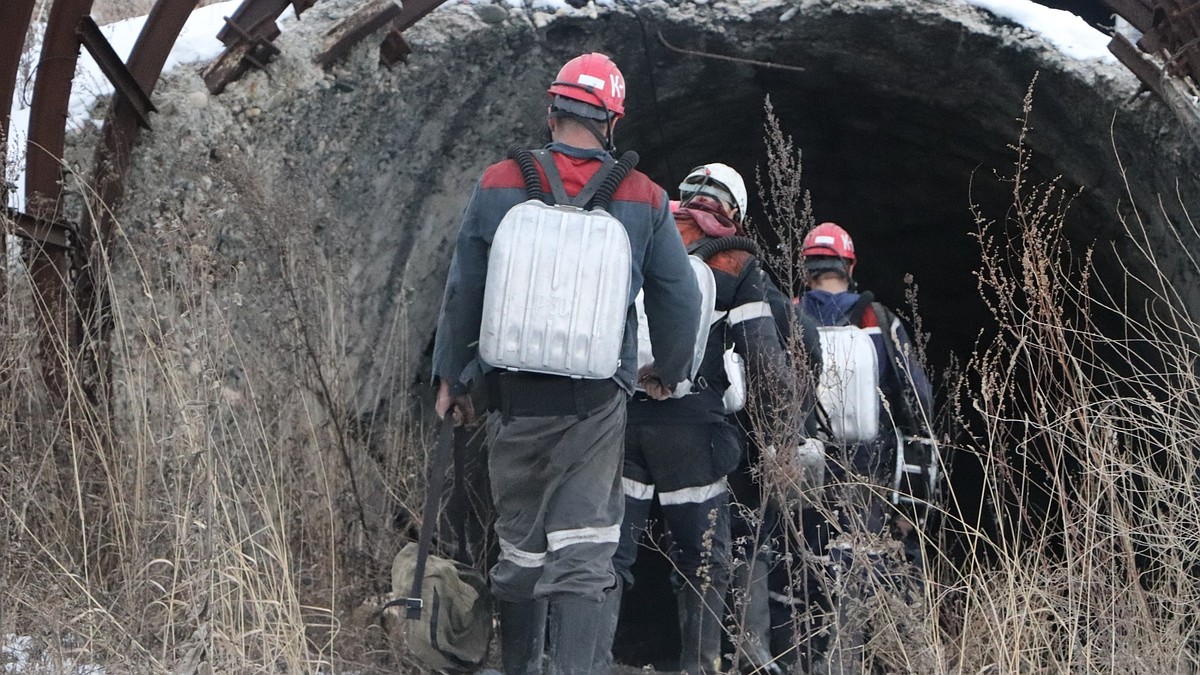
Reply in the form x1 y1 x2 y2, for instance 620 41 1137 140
479 147 638 380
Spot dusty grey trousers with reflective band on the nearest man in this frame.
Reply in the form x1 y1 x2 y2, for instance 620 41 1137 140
487 388 626 602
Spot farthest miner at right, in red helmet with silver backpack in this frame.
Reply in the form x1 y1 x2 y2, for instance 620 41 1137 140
773 222 936 673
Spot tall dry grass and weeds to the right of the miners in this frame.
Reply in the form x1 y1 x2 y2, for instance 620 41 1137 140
734 86 1200 673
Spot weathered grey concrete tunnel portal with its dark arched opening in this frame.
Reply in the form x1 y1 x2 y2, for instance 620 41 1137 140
100 0 1198 661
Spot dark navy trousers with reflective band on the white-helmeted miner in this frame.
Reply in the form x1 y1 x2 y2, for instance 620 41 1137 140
613 423 742 591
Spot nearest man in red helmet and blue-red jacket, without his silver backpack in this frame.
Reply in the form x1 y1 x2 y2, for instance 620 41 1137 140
433 53 700 675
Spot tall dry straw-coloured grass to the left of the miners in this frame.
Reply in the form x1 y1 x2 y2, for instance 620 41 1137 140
0 153 424 673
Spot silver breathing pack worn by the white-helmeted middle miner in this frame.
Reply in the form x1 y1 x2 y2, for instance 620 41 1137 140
637 235 758 414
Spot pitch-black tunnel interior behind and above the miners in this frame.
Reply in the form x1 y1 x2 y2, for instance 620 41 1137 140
600 66 1012 668
